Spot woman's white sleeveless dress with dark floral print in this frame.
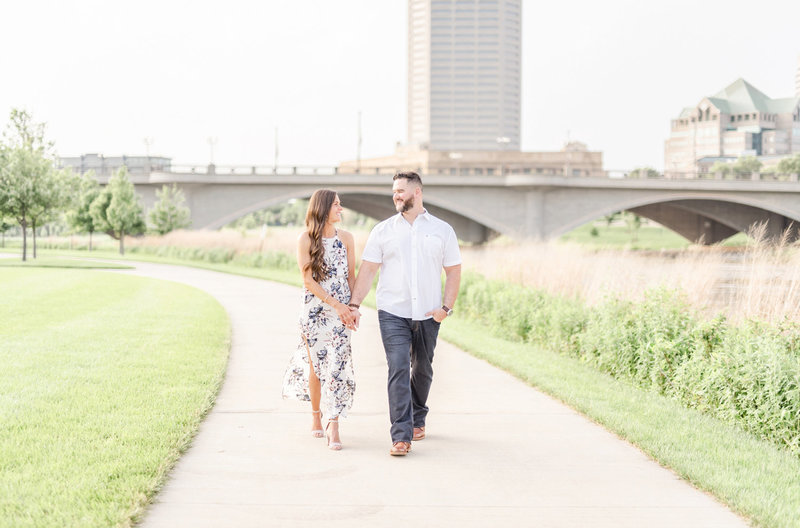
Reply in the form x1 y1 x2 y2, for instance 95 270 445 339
283 231 356 419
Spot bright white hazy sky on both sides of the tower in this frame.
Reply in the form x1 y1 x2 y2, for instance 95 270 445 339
0 0 800 169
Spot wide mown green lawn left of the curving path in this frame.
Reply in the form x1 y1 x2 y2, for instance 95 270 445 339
0 268 230 528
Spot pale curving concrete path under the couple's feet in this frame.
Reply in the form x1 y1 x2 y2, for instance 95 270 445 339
112 263 747 528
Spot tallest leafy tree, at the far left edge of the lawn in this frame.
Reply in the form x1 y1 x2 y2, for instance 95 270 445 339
0 108 65 261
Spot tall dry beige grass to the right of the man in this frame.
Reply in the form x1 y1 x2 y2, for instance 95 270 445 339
462 226 800 322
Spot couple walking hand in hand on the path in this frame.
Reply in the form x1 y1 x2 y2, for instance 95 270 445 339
283 172 461 456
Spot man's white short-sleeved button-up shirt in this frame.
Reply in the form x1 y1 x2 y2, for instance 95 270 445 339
361 211 461 321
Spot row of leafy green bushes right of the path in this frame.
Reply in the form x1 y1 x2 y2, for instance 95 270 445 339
458 273 800 455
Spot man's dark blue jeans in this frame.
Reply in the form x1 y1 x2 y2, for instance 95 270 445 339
378 310 439 442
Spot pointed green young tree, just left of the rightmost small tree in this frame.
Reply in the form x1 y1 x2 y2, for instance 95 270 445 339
89 167 145 255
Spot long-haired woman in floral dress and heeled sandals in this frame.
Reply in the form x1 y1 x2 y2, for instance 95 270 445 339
283 189 355 451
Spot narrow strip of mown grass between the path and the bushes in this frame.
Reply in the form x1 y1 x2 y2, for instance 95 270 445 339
3 248 800 528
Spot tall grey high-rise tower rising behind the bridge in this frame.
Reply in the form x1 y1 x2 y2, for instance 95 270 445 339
407 0 522 151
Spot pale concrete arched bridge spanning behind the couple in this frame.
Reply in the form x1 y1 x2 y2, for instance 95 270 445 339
106 166 800 244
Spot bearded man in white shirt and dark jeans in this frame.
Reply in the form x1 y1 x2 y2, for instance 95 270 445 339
350 172 461 456
